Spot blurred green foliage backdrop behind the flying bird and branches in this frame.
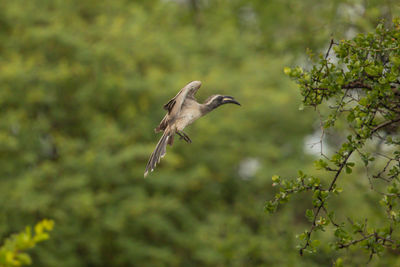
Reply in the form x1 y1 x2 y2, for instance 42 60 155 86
0 0 400 267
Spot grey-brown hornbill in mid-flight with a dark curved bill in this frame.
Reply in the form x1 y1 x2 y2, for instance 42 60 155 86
144 81 240 177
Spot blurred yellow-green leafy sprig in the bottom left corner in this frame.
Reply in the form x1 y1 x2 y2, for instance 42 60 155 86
0 219 54 267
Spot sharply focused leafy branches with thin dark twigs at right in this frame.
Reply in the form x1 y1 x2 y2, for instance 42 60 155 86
266 19 400 259
